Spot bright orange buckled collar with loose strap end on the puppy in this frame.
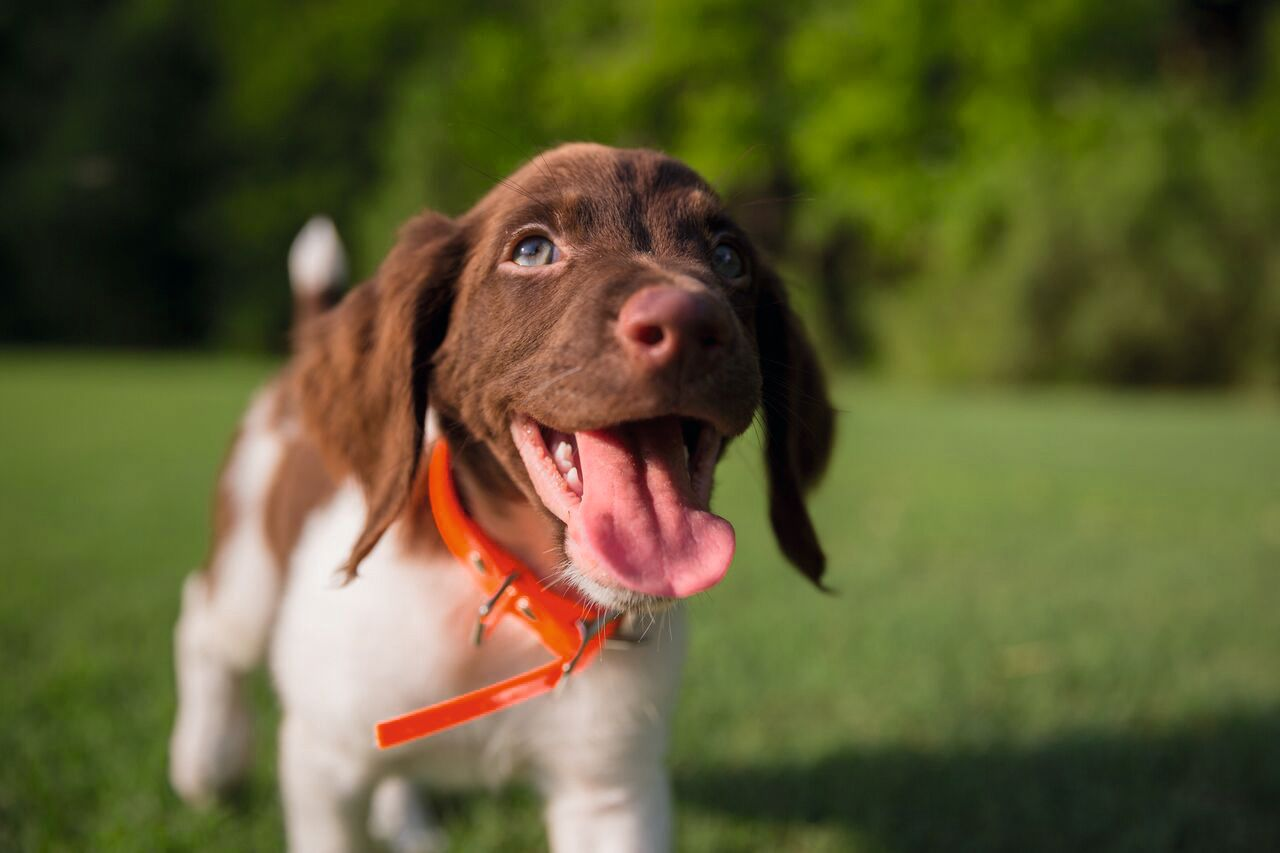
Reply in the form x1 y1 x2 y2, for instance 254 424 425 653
375 439 618 749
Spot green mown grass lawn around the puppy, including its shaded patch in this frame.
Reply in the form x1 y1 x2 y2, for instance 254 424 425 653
0 353 1280 852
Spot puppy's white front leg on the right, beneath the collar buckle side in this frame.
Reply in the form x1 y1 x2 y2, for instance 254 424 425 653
541 761 671 853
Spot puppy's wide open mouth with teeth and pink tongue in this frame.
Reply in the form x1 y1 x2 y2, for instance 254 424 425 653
511 415 733 598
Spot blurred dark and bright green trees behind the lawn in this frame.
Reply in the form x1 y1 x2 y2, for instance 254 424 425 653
0 0 1280 386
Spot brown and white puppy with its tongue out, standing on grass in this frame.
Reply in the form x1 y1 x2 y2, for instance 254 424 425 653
170 145 832 853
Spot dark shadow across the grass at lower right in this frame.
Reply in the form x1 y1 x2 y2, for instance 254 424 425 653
676 712 1280 852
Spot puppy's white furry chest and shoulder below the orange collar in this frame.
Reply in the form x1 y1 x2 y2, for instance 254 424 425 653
271 483 684 786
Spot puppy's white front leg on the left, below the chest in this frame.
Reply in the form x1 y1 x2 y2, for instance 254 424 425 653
280 716 374 853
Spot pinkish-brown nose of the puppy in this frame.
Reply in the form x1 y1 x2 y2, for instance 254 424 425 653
617 286 730 370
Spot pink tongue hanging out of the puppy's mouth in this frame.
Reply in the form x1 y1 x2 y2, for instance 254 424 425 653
568 418 733 597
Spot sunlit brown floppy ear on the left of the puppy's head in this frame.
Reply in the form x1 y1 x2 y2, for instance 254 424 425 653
297 213 465 579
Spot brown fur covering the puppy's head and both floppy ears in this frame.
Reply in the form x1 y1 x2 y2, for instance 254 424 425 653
281 145 832 583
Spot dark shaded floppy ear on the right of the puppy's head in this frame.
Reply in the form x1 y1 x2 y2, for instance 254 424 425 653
755 263 835 588
